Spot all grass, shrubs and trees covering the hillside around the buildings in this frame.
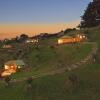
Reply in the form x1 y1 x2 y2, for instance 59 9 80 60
0 0 100 100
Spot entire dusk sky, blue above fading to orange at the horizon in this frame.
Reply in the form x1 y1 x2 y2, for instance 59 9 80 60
0 0 91 39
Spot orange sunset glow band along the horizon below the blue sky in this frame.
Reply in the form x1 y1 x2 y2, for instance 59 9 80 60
0 20 80 39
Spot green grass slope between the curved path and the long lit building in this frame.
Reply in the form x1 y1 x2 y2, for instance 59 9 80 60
12 44 92 79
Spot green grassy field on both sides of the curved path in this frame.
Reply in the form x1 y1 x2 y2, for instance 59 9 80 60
0 28 100 100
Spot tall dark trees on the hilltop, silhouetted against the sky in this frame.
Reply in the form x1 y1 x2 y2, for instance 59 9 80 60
80 0 100 28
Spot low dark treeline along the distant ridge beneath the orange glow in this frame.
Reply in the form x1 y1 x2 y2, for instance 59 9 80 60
0 28 76 47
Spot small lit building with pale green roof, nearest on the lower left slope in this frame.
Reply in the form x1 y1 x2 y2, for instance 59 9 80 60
4 60 25 73
